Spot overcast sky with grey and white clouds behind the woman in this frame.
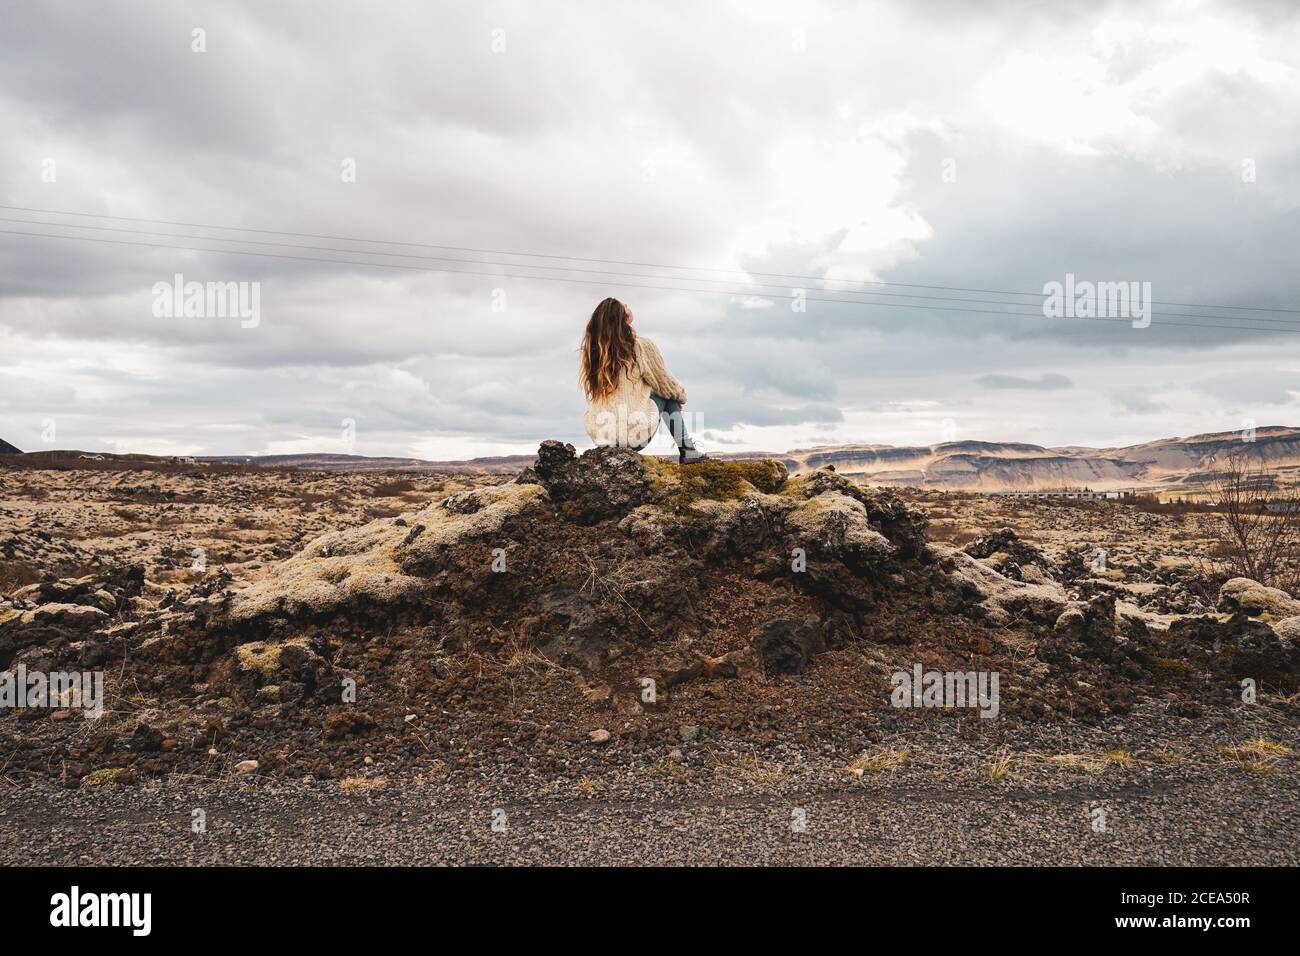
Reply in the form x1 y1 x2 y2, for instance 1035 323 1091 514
0 0 1300 458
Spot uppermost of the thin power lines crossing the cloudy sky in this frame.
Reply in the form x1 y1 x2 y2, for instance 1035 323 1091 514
0 204 1300 317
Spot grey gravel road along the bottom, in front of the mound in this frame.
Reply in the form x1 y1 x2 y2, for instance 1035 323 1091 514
0 771 1300 866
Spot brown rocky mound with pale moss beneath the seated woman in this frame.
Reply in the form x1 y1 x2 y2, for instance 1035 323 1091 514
0 442 1300 780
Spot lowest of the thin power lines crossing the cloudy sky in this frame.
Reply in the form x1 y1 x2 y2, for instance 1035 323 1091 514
0 229 1300 333
